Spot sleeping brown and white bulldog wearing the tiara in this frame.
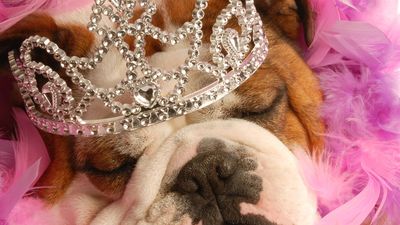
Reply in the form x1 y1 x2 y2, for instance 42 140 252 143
0 0 324 225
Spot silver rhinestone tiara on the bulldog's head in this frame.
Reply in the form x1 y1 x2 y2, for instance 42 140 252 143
9 0 268 136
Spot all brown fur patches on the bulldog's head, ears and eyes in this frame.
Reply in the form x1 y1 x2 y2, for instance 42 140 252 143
0 0 324 202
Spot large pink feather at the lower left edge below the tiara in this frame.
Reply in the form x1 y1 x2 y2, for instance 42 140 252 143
0 109 50 221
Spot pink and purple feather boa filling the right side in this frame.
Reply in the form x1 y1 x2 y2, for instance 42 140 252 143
300 0 400 225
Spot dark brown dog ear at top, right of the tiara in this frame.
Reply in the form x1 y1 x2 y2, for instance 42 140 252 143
255 0 315 45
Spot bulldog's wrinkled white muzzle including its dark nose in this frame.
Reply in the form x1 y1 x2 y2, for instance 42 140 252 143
45 120 318 225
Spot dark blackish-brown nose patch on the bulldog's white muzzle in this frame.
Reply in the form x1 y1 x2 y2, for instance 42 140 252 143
174 138 273 225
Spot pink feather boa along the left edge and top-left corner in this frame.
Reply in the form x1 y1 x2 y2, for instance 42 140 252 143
0 0 92 225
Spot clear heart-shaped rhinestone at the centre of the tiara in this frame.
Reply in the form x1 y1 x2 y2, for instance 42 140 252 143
133 83 159 108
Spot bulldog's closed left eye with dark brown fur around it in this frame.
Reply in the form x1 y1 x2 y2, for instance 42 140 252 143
73 136 140 198
